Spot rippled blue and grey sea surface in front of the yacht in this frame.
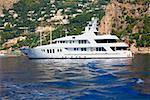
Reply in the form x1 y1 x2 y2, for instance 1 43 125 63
0 55 150 100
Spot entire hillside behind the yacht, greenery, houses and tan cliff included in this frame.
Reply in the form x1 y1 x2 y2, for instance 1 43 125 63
0 0 150 49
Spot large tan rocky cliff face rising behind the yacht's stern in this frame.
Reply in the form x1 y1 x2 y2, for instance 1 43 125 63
100 0 150 34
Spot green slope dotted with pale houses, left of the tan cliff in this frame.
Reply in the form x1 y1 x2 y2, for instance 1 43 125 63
0 0 108 48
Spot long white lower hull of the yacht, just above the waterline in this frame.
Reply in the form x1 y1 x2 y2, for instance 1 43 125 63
21 49 133 59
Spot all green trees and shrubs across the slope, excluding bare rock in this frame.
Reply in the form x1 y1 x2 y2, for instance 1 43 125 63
0 0 150 48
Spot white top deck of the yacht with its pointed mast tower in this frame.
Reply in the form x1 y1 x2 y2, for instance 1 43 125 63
53 19 119 44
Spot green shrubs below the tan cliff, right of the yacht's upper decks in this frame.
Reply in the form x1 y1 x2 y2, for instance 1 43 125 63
113 16 150 47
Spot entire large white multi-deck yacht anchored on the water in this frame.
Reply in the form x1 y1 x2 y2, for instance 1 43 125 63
21 18 133 59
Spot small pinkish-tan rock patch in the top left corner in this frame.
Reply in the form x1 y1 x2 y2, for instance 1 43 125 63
0 0 19 14
